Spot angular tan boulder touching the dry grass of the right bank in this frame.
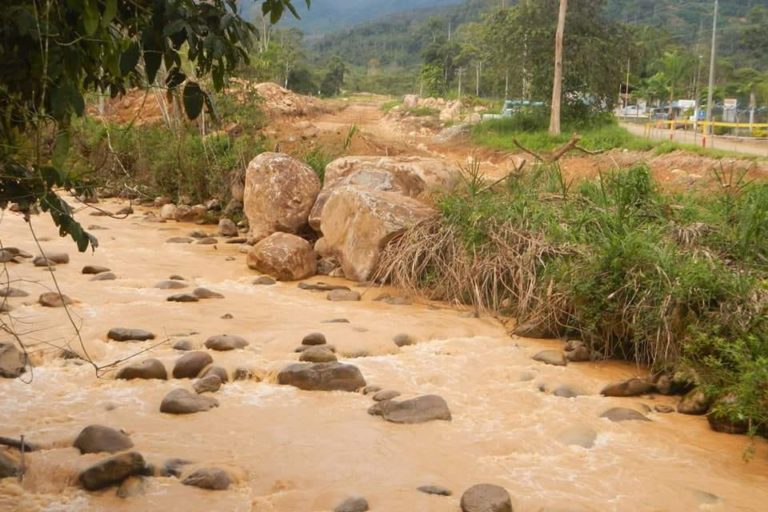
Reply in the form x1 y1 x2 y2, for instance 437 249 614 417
321 186 435 281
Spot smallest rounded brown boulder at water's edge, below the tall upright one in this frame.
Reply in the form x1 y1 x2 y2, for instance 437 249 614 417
247 233 317 281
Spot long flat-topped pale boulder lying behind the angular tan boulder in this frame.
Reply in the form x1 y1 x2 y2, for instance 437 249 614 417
309 156 460 231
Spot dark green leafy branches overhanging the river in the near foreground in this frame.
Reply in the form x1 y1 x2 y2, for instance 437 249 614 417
0 0 310 251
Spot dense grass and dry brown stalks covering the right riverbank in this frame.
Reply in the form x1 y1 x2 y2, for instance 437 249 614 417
380 161 768 428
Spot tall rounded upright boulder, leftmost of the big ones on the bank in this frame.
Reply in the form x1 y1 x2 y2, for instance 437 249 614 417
243 153 320 240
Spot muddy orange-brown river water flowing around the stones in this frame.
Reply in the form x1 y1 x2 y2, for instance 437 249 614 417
0 205 768 512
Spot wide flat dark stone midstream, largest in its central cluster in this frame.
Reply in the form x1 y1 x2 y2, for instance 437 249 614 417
277 362 365 391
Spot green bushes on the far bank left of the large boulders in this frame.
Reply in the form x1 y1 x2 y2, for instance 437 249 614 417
67 94 266 202
